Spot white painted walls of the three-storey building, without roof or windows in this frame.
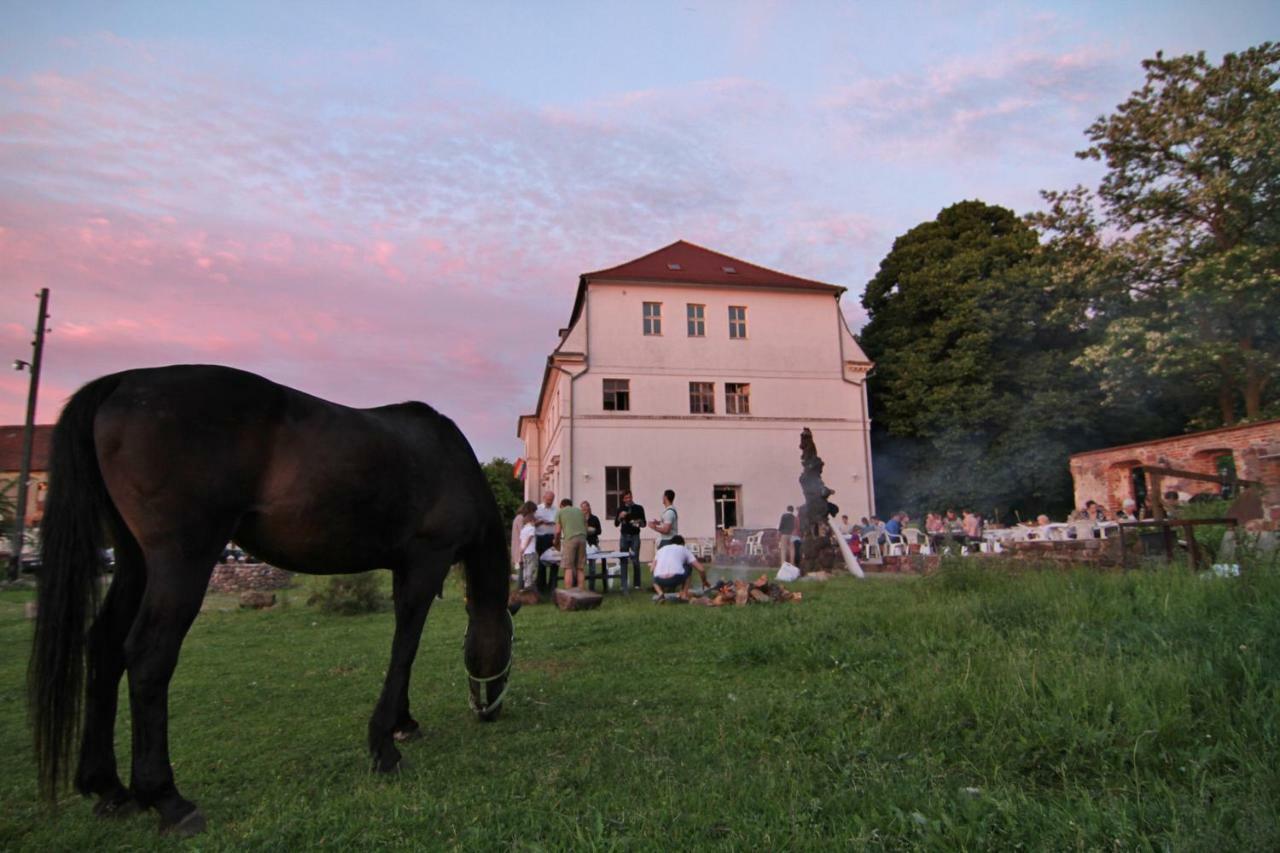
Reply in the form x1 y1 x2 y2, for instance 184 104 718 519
521 275 873 543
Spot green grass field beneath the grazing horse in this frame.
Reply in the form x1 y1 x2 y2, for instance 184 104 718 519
0 566 1280 850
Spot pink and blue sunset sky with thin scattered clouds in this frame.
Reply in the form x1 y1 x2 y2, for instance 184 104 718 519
0 0 1280 459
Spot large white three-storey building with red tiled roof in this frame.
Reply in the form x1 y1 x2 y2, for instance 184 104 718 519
517 241 874 547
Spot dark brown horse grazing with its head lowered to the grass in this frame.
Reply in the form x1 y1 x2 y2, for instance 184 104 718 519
29 365 512 834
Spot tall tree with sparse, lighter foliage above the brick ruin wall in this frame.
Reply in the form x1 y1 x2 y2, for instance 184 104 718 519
1033 42 1280 427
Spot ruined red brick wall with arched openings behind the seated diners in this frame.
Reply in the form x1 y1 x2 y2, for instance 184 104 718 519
1071 420 1280 530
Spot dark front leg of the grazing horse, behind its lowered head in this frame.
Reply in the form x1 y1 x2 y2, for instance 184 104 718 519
369 560 448 772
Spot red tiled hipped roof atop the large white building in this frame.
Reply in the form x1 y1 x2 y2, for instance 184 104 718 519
582 240 845 293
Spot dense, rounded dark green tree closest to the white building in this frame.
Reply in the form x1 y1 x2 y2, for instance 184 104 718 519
860 201 1096 515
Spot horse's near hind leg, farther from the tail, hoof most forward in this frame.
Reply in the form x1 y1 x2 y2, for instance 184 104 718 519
124 545 225 835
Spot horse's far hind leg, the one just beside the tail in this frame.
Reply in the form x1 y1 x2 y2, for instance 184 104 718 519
76 525 146 816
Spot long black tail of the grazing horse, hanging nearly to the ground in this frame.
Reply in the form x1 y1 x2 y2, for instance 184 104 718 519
27 375 119 799
